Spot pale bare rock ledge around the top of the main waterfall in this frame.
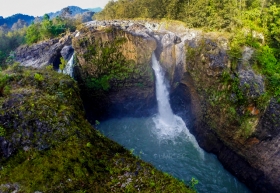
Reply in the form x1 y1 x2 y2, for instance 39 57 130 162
82 20 202 85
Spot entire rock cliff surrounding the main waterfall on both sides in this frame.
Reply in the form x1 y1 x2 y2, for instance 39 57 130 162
13 21 280 192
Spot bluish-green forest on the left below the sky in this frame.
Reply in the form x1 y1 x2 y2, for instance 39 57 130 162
0 8 82 68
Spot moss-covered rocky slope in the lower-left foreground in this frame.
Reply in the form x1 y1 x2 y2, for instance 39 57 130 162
0 66 193 192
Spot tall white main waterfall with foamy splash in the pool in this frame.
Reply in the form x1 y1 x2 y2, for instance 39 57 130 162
152 53 204 155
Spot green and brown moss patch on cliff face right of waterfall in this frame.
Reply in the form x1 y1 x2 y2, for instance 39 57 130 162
186 39 269 143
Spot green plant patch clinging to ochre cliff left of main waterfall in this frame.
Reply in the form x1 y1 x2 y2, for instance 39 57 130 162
84 34 134 91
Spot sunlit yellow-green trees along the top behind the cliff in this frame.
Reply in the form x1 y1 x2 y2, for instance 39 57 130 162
97 0 279 30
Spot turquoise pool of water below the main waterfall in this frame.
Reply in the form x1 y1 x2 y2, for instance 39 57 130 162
97 116 250 193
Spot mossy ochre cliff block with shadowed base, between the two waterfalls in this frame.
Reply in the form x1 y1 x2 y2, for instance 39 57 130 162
73 26 157 122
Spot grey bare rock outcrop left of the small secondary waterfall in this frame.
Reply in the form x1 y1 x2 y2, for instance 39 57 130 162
15 35 71 69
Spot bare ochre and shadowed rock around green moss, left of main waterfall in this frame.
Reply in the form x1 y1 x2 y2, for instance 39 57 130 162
73 24 156 121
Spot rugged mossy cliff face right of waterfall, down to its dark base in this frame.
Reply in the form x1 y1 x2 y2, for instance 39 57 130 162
182 34 280 192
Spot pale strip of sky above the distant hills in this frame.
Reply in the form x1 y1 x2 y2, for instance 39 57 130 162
0 0 109 17
